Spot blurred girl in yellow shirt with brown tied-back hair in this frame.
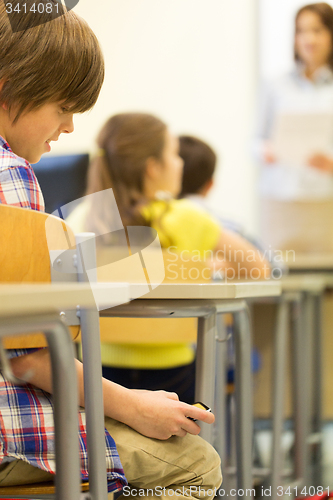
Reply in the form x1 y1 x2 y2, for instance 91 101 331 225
68 113 269 403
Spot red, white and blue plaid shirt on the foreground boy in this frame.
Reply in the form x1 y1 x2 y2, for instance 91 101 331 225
0 136 127 492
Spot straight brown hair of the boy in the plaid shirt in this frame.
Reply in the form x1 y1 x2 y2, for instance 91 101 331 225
0 0 104 121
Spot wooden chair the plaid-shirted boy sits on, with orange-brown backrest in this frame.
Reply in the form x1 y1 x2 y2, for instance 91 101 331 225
0 205 107 500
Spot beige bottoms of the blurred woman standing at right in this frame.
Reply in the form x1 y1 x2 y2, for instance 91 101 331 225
260 198 333 253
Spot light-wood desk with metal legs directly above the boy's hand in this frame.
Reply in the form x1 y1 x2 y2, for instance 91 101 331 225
101 281 281 489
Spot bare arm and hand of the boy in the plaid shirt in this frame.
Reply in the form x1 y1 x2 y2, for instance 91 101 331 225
11 349 214 439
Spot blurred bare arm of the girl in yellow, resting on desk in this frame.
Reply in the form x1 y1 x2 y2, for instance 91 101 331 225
214 229 271 279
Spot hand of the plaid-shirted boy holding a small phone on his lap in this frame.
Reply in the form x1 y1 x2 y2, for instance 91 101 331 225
123 390 215 439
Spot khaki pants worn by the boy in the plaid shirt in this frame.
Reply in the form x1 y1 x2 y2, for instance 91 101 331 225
0 418 222 500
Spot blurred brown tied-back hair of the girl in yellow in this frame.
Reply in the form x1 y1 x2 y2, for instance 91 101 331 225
87 113 167 227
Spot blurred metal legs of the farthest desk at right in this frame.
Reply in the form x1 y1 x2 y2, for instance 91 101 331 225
249 277 326 500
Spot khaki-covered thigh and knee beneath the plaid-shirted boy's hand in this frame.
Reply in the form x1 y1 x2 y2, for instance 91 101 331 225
105 418 221 488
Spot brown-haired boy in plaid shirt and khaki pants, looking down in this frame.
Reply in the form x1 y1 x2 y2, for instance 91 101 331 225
0 0 221 500
